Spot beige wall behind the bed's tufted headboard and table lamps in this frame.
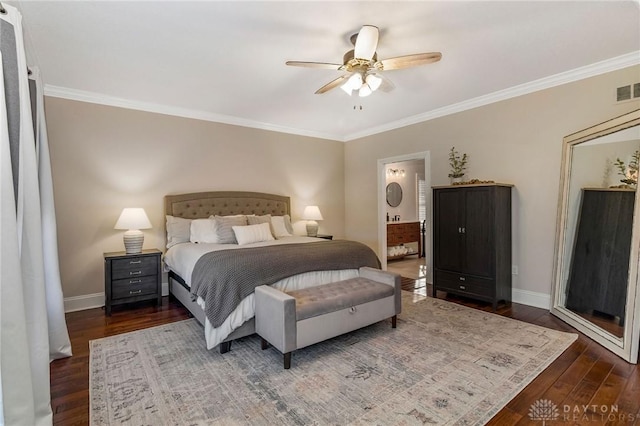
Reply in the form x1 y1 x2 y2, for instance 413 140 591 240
45 97 344 298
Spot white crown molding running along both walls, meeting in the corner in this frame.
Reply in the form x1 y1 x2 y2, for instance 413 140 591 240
44 51 640 142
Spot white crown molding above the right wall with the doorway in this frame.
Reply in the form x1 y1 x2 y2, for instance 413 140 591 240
344 51 640 141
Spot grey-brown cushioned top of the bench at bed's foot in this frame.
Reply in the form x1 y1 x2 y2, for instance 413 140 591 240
287 277 395 321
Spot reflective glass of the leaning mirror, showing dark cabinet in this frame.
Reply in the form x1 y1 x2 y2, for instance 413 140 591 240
558 127 640 337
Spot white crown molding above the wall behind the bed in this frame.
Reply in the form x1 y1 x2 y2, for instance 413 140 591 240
44 84 344 142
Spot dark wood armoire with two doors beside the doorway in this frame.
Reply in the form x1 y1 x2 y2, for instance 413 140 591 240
433 184 512 310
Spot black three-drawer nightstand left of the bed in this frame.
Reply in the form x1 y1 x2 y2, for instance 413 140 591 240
104 249 162 316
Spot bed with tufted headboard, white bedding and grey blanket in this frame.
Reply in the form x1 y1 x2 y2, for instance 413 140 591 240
164 191 380 353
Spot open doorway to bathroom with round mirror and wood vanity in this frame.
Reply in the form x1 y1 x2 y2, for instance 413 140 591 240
378 151 432 282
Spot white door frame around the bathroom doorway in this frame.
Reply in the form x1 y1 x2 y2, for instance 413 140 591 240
378 151 433 274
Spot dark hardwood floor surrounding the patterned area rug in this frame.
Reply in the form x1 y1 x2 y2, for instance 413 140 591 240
51 288 640 426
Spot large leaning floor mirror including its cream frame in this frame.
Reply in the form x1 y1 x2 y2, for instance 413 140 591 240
551 110 640 364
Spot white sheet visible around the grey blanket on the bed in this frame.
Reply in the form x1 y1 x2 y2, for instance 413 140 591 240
164 236 358 349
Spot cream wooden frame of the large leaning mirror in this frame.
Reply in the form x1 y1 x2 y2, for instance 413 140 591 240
551 110 640 364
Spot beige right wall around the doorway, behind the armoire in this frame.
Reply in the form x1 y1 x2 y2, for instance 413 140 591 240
345 66 640 295
